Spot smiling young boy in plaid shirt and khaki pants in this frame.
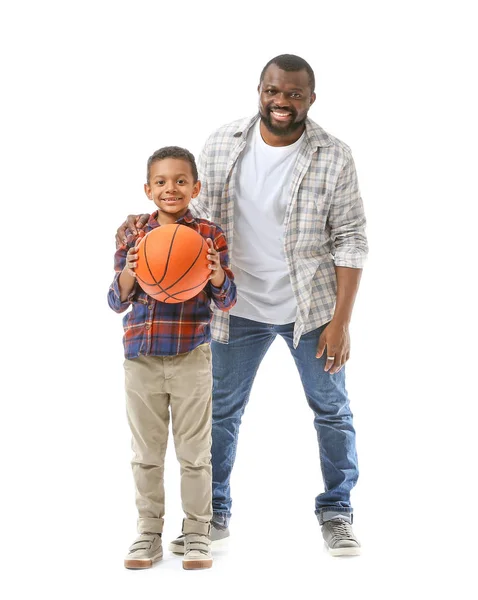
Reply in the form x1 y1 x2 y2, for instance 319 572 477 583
108 146 236 569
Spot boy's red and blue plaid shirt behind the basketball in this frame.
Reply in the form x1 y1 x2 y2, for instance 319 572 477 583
108 211 236 358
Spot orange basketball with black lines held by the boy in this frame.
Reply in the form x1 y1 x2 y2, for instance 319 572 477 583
135 224 211 303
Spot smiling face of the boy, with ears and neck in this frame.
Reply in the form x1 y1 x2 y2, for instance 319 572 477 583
144 158 201 224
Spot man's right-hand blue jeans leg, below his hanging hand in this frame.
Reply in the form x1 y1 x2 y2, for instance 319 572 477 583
276 325 358 525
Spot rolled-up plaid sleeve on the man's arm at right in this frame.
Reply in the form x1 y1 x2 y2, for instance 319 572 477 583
328 156 368 269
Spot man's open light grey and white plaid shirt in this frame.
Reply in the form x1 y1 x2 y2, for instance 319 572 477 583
190 115 368 347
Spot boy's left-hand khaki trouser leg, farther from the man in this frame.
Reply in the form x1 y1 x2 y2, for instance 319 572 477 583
124 356 169 533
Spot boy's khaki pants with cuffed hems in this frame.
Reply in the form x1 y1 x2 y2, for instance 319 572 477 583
124 344 212 534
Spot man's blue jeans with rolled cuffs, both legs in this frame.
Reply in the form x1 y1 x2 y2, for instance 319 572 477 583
212 315 358 526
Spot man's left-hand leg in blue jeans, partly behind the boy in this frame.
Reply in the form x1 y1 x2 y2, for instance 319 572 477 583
212 315 276 528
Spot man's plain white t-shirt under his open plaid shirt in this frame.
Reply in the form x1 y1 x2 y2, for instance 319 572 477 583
230 120 304 325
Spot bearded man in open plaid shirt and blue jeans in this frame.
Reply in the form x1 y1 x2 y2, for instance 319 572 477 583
117 54 368 556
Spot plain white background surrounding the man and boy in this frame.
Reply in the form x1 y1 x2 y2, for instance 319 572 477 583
0 0 478 599
